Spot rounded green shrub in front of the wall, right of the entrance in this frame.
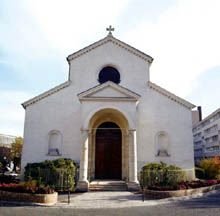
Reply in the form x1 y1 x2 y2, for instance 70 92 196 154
140 162 185 187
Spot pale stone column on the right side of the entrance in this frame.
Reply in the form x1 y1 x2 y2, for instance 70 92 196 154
128 130 139 190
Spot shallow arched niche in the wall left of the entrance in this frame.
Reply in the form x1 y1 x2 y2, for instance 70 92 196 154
48 130 62 156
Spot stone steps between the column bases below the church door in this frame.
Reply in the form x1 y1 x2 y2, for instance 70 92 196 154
89 180 128 191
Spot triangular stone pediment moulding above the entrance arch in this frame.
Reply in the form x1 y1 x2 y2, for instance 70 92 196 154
78 81 140 101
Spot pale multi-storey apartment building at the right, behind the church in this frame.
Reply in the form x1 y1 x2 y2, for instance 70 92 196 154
193 108 220 163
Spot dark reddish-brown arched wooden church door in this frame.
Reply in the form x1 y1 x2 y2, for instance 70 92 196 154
95 122 122 179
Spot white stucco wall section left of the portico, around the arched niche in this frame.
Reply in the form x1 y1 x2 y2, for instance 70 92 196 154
22 86 81 171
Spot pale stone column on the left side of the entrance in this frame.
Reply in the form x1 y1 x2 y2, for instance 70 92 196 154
77 130 89 191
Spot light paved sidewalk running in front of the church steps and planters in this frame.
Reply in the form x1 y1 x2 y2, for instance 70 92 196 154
0 191 215 209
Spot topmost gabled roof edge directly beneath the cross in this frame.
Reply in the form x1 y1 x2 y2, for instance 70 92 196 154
67 34 153 63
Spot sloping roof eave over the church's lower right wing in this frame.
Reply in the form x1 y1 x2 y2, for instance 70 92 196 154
148 81 196 109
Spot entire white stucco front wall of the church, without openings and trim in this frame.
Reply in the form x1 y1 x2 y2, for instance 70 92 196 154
22 38 194 179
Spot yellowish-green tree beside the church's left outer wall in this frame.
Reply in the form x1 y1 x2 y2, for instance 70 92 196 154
10 137 23 168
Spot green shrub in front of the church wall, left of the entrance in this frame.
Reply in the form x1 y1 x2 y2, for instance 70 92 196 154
24 158 76 191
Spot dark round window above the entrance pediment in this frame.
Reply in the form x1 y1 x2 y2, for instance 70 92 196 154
98 67 120 84
